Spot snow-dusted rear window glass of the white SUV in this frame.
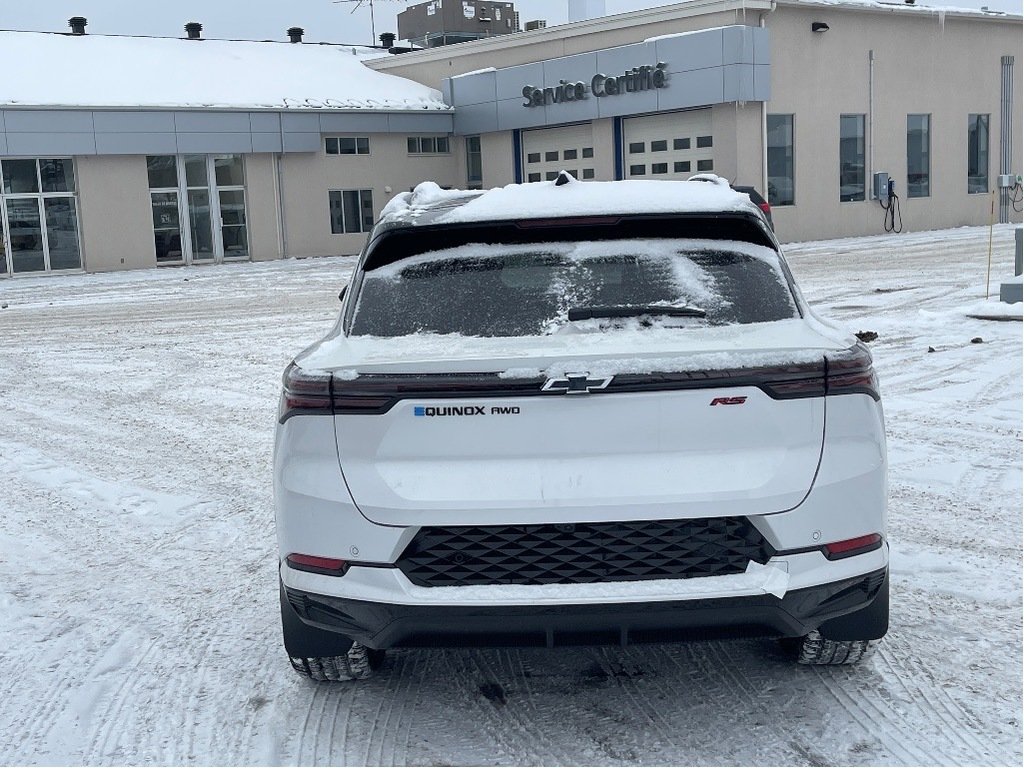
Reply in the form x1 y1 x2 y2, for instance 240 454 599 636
349 240 799 337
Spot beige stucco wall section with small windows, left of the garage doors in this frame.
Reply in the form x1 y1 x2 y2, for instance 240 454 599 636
281 133 458 257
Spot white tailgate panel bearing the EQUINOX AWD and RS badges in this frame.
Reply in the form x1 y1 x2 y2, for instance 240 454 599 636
335 385 825 525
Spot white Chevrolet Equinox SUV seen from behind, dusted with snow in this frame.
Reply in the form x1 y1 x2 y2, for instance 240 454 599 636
274 175 889 680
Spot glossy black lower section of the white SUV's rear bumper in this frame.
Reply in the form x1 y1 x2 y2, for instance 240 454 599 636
286 568 886 648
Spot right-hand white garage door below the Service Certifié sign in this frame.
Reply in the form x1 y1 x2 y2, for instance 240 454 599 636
623 110 715 179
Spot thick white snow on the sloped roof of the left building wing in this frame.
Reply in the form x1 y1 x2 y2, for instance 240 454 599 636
0 31 451 111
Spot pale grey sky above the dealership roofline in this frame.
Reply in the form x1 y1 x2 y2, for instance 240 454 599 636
0 0 1021 45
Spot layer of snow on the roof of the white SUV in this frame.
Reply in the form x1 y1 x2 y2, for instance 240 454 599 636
381 174 758 224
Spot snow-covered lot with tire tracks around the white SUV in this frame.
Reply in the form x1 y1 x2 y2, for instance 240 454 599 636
0 227 1022 765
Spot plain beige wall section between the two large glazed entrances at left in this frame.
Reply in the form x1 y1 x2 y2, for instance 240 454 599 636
75 155 157 272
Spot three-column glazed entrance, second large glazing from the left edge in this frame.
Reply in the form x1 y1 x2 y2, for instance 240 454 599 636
145 155 249 264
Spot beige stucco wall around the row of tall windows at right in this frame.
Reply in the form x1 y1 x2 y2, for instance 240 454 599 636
767 7 1024 240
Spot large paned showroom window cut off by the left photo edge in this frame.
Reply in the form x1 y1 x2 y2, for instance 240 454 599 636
0 158 82 274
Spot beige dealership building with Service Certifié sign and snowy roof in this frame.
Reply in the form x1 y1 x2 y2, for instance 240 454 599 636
0 0 1024 276
